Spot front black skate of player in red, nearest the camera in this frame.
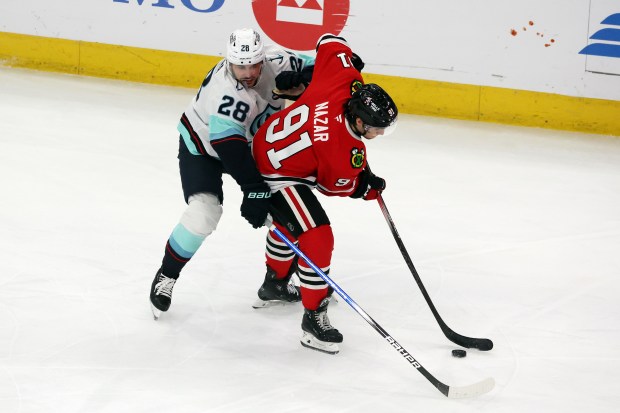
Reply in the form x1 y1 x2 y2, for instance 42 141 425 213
301 298 342 354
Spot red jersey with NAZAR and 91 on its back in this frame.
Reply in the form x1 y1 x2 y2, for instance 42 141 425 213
252 35 366 196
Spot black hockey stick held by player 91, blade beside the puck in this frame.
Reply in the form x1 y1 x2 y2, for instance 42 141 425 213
377 194 493 351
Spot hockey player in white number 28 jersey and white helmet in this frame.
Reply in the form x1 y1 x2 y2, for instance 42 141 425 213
150 29 314 319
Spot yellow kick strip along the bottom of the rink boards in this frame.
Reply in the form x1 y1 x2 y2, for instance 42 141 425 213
0 32 620 136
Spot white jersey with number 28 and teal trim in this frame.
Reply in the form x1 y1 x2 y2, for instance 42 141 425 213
177 45 314 159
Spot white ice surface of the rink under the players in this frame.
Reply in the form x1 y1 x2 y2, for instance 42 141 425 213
0 69 620 413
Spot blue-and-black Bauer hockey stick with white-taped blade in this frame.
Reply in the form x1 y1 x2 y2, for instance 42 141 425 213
266 218 495 399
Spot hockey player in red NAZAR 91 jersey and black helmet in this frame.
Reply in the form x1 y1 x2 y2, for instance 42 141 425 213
252 34 398 354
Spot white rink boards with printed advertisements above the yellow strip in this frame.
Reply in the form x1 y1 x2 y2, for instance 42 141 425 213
0 0 620 100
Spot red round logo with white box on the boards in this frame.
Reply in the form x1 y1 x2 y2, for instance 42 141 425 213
252 0 349 50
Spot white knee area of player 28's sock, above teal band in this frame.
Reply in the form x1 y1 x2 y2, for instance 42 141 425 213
181 193 223 237
